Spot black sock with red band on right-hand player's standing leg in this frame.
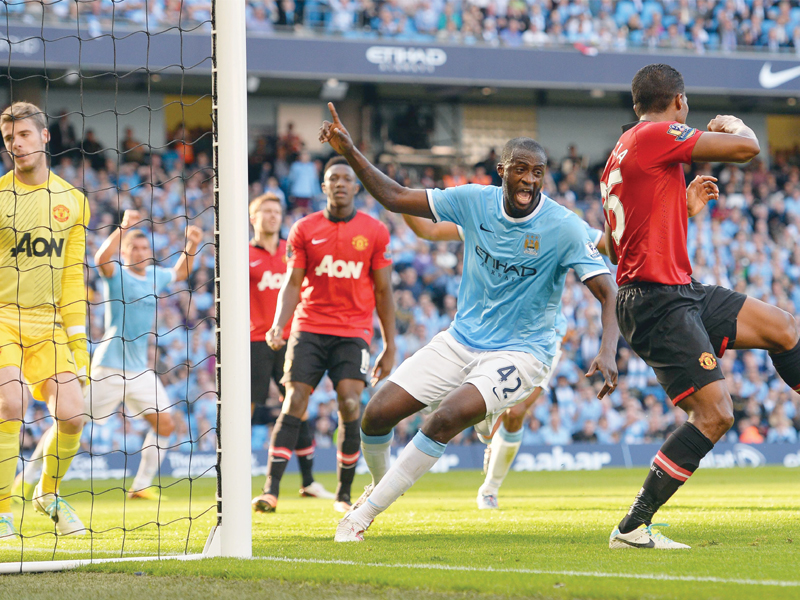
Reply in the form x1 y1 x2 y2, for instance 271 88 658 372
619 422 714 533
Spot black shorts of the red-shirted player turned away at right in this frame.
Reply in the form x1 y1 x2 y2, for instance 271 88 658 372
617 280 747 404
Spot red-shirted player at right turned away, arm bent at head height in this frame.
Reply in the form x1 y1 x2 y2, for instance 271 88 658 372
600 64 800 549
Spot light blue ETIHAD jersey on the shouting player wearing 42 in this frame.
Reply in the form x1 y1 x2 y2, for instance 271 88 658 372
427 185 609 365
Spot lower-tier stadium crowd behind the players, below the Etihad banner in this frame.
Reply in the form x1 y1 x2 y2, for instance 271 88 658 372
4 115 800 452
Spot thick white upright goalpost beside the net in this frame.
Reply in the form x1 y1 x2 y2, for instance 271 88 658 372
206 0 252 558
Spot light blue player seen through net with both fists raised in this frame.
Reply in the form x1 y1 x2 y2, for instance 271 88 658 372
24 210 203 500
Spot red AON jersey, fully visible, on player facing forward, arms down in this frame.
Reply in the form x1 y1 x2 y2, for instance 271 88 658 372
289 211 392 343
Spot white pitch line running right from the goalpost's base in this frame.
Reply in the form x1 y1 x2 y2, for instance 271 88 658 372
253 556 800 587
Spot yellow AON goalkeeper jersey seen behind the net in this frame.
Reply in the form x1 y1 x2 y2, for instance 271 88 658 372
0 171 89 344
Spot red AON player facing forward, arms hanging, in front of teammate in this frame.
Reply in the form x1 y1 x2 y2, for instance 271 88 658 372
253 157 395 512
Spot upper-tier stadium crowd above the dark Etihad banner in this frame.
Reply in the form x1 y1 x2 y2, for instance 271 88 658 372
9 0 800 53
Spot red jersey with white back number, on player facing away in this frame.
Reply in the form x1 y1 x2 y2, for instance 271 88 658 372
600 121 702 285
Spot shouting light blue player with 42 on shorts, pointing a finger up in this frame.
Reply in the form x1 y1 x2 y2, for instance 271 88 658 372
320 104 619 542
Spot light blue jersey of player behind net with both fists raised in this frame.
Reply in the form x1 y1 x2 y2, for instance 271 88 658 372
92 266 175 373
